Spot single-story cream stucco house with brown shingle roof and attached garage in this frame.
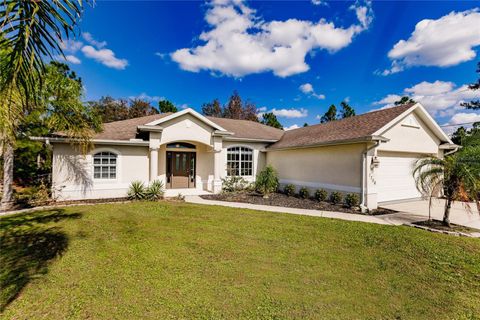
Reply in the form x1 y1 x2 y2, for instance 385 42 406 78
35 103 455 209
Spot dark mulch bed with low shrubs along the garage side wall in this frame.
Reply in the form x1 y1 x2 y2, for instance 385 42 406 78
200 192 396 215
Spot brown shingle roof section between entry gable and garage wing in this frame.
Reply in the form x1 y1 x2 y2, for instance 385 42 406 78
207 117 285 140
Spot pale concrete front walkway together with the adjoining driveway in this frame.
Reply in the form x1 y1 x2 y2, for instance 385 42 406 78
185 196 480 235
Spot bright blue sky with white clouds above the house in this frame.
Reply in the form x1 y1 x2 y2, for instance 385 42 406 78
61 0 480 131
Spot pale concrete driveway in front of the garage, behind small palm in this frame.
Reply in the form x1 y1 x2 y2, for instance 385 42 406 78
378 199 480 229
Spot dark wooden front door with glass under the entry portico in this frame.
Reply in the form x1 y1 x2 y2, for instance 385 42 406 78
167 151 196 189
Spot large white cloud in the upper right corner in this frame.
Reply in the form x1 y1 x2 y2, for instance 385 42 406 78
382 9 480 75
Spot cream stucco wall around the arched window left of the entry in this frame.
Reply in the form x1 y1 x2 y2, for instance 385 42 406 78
52 143 149 200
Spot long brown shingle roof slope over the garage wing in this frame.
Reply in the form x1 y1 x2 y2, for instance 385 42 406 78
269 103 414 149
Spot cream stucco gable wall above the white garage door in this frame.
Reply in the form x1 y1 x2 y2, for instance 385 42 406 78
378 112 440 155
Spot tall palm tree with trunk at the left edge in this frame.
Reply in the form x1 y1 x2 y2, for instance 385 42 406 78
0 0 89 209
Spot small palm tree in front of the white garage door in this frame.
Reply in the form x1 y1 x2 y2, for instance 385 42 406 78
413 146 480 226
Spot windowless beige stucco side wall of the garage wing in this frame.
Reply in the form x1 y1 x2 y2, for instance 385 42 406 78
266 144 365 193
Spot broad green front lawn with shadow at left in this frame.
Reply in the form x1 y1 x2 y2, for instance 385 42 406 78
0 203 480 319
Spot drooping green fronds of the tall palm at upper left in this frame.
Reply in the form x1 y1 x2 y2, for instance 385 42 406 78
0 0 84 102
